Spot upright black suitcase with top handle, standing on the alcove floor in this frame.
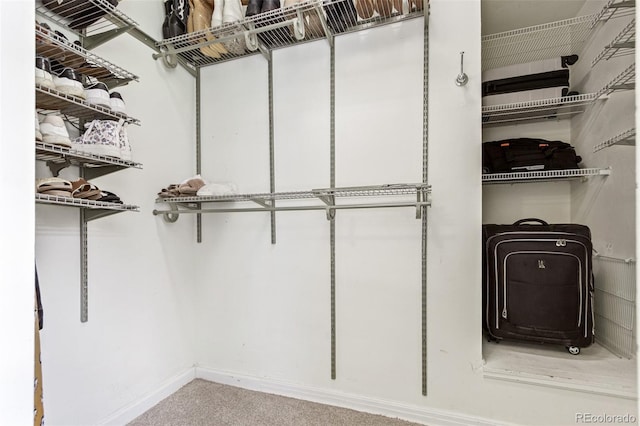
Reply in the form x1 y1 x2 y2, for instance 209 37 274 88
482 219 593 355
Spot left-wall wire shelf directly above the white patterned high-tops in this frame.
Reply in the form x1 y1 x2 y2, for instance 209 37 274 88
36 83 140 125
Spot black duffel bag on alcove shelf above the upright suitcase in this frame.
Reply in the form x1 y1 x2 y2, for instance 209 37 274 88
482 138 582 173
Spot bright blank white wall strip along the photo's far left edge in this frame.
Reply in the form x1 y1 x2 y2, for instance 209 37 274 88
0 1 35 424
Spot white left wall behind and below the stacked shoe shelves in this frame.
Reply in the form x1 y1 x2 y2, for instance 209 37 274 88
32 1 196 425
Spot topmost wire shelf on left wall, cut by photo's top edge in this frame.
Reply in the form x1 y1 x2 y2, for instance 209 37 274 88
36 0 138 37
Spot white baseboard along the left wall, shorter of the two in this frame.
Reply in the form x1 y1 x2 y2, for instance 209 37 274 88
98 368 196 426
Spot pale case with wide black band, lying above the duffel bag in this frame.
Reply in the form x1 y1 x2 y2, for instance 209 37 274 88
482 55 578 106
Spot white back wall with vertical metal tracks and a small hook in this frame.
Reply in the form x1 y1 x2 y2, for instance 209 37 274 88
197 0 635 424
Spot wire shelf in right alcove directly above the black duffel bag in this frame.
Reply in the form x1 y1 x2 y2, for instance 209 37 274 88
482 93 599 126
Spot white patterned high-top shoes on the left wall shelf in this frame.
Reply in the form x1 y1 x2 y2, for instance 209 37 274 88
72 120 131 161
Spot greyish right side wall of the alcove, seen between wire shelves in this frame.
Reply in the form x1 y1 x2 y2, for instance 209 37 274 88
571 1 636 259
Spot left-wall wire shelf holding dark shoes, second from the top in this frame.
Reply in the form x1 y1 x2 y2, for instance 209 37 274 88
36 23 138 88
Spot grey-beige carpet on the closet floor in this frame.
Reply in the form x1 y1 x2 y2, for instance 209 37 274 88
129 379 416 426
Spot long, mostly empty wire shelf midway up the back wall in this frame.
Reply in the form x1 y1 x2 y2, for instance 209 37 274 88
153 184 431 215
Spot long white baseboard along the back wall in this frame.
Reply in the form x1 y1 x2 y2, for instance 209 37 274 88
195 367 505 426
